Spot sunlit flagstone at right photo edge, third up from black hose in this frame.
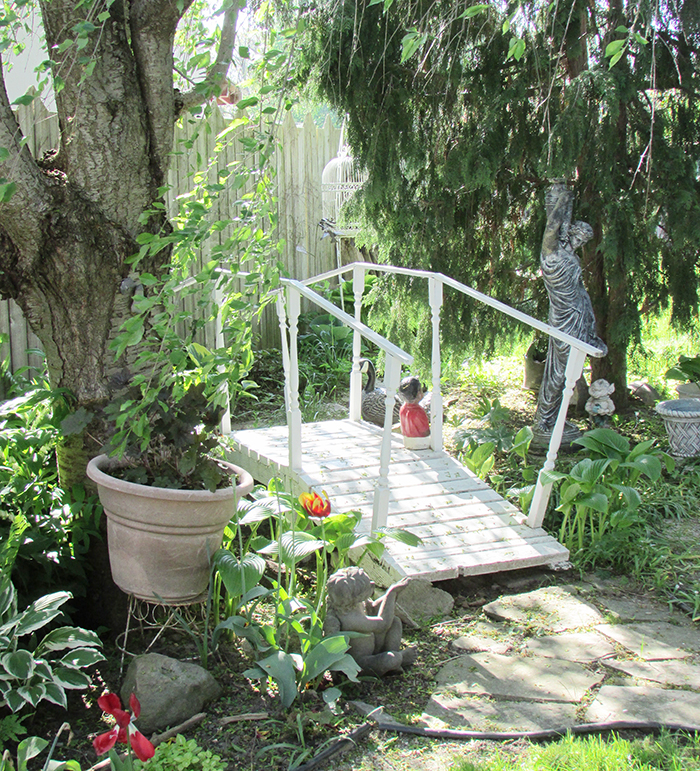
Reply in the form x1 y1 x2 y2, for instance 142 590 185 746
596 621 700 661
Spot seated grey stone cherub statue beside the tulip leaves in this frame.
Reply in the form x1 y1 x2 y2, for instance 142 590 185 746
323 567 416 677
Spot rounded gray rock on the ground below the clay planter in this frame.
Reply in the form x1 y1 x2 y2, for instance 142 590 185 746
121 653 221 734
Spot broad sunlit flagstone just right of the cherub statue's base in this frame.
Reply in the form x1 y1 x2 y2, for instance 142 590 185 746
436 653 603 702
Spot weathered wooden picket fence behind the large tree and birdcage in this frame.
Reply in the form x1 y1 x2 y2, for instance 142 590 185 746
0 99 340 380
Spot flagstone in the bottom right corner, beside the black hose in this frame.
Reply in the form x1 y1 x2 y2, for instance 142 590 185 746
586 685 700 730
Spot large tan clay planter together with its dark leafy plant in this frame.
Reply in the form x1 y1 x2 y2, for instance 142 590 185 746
87 383 253 604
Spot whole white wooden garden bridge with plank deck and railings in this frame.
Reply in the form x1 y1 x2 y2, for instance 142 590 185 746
231 262 599 585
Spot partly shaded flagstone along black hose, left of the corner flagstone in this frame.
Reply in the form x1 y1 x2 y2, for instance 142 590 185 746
421 690 576 732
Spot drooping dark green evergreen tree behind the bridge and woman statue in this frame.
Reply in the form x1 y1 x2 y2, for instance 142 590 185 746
303 0 700 407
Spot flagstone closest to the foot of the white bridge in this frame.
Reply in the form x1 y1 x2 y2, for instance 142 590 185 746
484 586 604 632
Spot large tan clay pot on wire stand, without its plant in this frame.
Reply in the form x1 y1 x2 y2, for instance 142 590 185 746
87 455 253 605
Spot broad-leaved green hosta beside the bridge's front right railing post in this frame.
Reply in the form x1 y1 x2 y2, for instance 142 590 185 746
542 428 674 553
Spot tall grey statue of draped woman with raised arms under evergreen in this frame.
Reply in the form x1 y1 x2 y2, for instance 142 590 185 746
534 182 608 445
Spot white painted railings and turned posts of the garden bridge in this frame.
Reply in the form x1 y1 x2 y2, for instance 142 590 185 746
277 262 602 528
